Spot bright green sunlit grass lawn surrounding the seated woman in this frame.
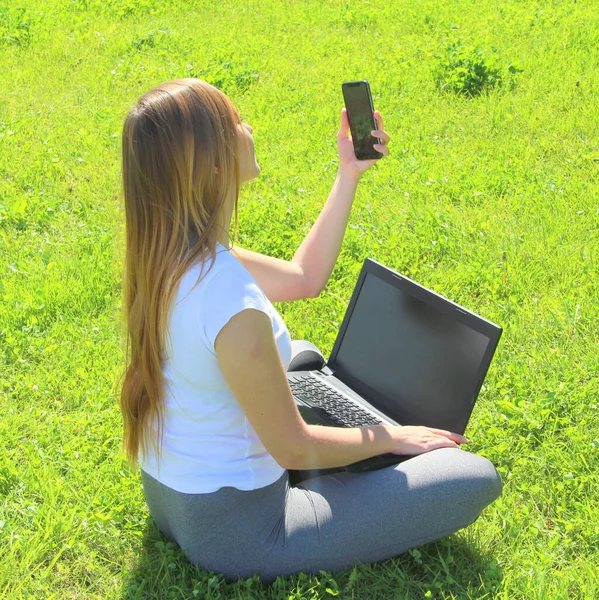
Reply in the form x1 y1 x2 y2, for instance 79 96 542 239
0 0 599 600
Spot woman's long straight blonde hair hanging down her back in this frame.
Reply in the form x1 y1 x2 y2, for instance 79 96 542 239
120 79 241 465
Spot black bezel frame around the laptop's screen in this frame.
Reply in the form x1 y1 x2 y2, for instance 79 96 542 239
327 258 503 434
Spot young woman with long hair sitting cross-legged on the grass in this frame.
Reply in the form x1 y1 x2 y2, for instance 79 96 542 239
121 79 502 582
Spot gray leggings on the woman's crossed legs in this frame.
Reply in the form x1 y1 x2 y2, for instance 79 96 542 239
142 448 502 583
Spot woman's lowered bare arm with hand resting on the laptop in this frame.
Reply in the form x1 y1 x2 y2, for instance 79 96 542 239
215 309 464 469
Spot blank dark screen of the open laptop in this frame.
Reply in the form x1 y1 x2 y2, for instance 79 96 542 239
334 274 489 432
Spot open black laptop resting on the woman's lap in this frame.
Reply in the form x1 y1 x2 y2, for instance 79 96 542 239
287 258 502 476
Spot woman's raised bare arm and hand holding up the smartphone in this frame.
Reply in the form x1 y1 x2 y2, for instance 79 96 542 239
233 109 390 302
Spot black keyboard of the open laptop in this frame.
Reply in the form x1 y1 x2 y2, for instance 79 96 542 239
289 375 383 427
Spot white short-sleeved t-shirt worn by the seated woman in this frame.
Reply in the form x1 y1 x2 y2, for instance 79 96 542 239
140 244 291 494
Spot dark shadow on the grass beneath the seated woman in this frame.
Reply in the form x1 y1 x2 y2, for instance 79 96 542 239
122 517 503 600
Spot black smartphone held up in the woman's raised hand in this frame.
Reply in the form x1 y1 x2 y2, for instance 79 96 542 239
341 81 383 160
